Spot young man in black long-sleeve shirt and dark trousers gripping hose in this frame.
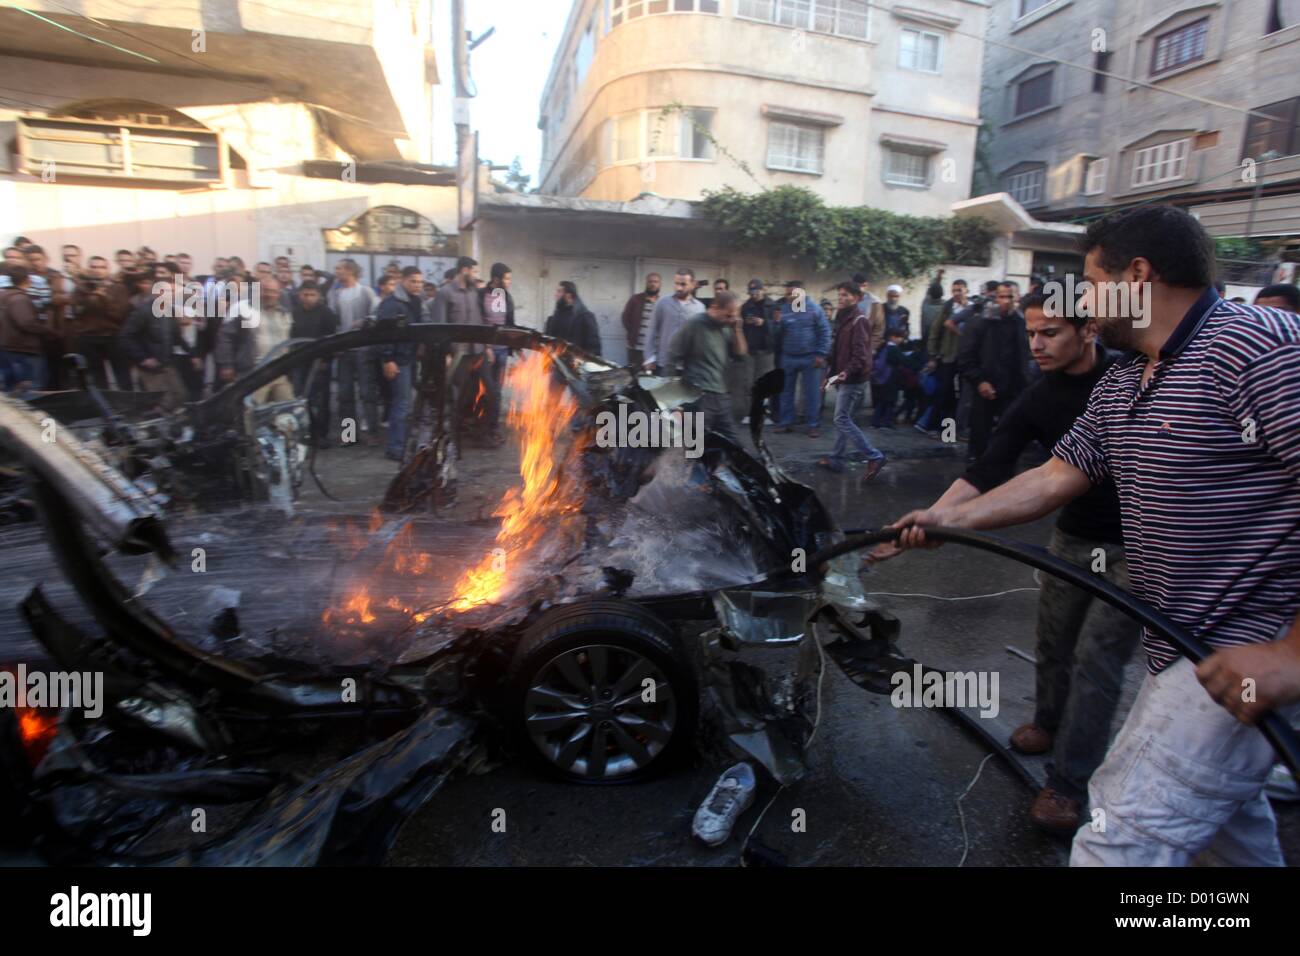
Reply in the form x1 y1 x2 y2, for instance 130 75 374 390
874 294 1140 834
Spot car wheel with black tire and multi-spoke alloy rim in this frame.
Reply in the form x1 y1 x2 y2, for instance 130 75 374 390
510 600 699 784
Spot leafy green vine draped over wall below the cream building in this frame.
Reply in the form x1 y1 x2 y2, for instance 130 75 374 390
701 186 997 280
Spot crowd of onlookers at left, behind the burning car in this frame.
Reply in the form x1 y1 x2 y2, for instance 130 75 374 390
0 243 533 459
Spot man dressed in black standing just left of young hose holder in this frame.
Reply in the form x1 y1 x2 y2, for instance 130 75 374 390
957 282 1030 459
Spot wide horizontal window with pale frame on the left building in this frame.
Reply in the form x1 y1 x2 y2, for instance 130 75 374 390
20 117 221 183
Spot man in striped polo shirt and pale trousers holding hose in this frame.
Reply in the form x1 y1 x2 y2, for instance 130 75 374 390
896 206 1300 866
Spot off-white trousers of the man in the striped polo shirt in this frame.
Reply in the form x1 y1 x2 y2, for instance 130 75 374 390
1070 657 1290 866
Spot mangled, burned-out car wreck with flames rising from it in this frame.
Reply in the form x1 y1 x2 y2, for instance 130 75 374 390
0 325 901 865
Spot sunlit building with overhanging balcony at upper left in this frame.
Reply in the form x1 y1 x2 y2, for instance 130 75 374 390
0 0 458 278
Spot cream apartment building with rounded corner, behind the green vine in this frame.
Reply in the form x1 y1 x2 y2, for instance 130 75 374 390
538 0 987 216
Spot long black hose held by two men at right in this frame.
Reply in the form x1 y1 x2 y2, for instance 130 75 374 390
787 528 1300 779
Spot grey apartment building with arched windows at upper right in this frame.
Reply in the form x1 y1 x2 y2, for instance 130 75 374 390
982 0 1300 244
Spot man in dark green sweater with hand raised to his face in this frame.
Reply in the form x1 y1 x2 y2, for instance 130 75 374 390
668 289 748 445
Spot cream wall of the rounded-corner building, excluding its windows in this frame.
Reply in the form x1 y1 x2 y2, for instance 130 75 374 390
542 0 985 215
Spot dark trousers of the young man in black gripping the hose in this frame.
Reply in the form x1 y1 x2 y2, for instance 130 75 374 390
1034 528 1141 803
